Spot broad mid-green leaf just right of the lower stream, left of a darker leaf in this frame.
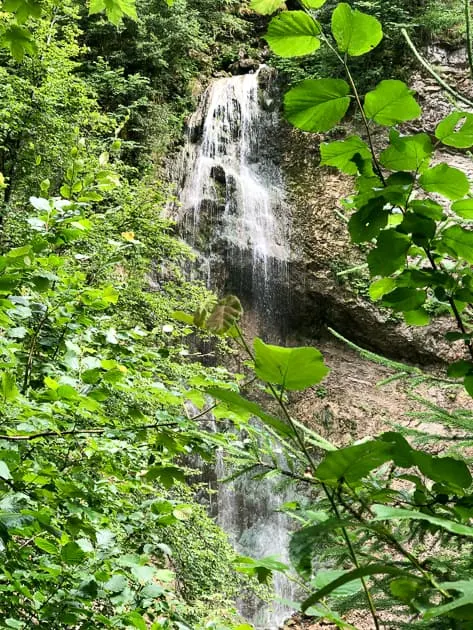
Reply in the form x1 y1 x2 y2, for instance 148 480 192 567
315 440 392 484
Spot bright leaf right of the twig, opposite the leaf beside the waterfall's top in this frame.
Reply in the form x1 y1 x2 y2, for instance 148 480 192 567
364 79 421 126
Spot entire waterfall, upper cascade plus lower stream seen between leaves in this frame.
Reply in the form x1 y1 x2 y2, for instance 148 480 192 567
173 66 295 630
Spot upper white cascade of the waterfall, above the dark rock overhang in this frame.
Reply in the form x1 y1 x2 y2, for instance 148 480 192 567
174 66 290 328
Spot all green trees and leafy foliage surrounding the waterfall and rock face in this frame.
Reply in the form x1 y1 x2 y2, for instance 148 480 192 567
0 0 473 630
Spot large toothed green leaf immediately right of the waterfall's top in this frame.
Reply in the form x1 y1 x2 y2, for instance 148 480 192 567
284 79 350 132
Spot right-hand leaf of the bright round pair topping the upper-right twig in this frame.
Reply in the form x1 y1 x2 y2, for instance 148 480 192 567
332 2 383 57
